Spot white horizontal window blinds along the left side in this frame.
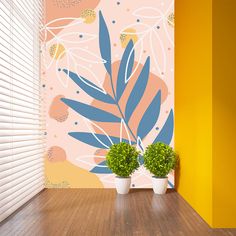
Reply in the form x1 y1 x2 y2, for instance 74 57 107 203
0 0 45 222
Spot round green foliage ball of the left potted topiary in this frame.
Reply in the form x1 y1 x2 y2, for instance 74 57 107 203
106 142 139 178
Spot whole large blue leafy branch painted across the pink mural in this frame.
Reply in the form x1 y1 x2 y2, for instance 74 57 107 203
58 11 173 178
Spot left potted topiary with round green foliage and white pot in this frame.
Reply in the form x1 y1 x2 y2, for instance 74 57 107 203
106 142 139 194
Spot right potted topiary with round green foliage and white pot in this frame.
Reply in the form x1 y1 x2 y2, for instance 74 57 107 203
143 142 177 194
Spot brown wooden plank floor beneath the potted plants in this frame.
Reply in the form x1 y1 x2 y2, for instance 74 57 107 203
0 189 236 236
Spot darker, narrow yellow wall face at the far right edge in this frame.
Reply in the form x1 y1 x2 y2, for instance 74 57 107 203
213 0 236 228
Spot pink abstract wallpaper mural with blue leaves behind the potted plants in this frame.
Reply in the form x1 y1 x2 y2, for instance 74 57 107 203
41 0 174 188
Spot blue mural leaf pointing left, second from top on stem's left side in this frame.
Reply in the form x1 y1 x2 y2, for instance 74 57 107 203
61 98 120 122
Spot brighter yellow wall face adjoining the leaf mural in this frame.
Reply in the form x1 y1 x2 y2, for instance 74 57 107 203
175 0 212 225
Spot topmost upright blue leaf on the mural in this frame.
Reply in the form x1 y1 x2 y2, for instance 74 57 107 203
99 11 111 76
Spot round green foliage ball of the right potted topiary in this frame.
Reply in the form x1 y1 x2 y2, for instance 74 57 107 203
143 142 177 178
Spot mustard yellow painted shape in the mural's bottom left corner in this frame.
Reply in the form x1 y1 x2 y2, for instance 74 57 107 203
45 160 103 188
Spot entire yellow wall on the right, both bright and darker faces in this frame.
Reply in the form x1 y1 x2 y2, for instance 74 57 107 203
175 0 236 228
